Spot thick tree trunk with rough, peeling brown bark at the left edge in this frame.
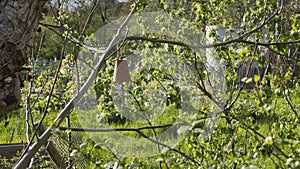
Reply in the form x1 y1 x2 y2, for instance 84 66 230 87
0 0 47 118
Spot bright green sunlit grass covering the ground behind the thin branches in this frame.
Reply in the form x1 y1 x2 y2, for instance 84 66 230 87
0 86 300 168
